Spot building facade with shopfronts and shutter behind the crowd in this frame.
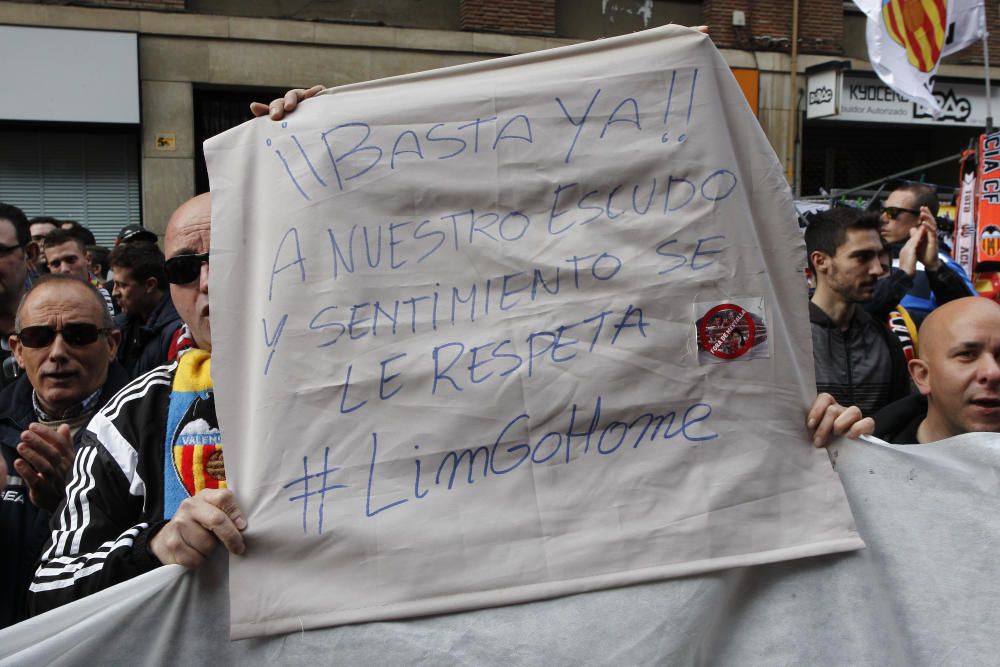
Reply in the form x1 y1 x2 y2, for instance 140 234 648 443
0 0 1000 243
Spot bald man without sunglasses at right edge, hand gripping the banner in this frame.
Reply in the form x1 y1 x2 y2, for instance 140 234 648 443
806 297 1000 447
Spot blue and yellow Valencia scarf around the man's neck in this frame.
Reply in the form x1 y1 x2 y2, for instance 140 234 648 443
163 348 226 519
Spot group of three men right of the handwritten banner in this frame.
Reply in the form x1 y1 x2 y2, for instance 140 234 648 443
805 183 1000 445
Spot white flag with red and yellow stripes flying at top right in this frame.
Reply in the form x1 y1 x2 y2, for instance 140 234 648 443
855 0 986 118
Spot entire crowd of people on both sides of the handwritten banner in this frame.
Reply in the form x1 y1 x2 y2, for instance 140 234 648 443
0 86 1000 627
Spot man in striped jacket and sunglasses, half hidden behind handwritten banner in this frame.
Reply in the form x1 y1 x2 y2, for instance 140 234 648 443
28 194 246 613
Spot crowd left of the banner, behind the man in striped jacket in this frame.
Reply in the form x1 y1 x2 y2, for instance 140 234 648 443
0 203 193 627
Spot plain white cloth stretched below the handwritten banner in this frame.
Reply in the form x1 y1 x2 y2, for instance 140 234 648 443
0 434 1000 666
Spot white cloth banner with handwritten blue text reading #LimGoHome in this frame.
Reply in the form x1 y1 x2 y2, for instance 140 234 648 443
206 27 861 637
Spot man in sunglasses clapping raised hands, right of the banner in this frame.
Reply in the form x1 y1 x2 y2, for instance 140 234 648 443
866 183 976 325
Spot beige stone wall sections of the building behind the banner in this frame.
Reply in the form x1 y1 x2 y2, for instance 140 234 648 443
0 0 992 219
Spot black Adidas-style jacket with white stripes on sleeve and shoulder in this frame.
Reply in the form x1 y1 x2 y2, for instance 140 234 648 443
28 362 177 615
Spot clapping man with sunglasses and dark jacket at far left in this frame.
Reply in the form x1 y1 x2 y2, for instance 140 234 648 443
0 275 128 627
